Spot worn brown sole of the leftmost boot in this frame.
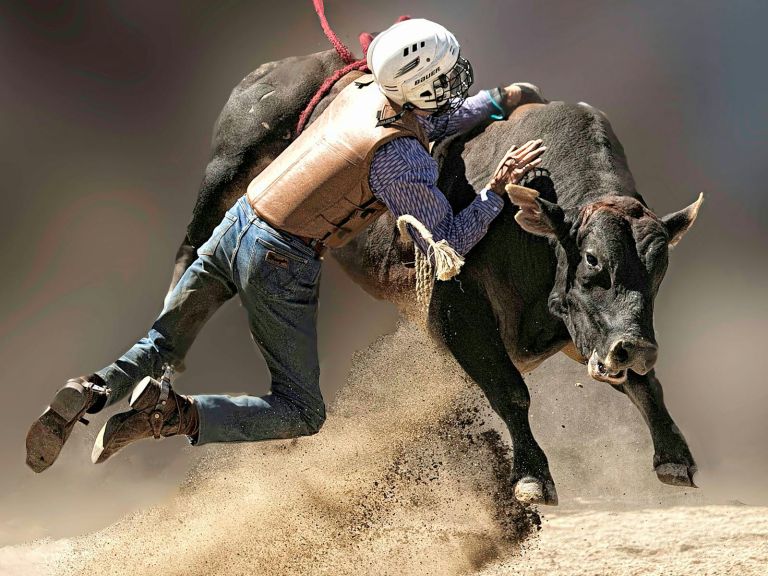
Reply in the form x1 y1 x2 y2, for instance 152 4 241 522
27 387 86 474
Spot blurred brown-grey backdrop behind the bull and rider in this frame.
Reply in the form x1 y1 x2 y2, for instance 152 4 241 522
0 0 768 545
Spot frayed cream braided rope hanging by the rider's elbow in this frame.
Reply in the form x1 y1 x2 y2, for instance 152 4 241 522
397 214 464 320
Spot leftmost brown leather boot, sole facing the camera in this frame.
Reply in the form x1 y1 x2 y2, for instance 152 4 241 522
27 374 109 473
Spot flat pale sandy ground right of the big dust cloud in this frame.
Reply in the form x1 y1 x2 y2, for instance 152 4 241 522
481 505 768 576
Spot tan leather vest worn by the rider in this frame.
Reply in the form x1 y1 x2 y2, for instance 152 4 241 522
248 75 429 248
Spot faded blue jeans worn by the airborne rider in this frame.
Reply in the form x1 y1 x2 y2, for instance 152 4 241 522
98 196 325 444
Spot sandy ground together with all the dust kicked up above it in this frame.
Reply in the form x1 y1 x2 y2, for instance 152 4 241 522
0 325 768 576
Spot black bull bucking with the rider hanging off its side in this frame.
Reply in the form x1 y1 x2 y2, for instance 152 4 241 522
171 51 701 504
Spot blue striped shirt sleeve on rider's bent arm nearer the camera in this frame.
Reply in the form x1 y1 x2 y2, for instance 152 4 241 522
369 137 504 255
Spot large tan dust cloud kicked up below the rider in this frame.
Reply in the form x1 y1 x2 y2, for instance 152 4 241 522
48 323 539 576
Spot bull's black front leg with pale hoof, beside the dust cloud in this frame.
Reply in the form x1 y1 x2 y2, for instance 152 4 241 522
430 279 557 505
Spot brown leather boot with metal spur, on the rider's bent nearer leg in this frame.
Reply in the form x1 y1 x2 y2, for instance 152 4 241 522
91 376 199 464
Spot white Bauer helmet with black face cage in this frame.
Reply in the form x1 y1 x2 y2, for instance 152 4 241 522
367 18 472 115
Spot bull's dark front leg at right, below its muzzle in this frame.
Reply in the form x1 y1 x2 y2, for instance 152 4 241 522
618 370 696 487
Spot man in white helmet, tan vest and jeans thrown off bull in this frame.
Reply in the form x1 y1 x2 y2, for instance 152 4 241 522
27 19 545 472
